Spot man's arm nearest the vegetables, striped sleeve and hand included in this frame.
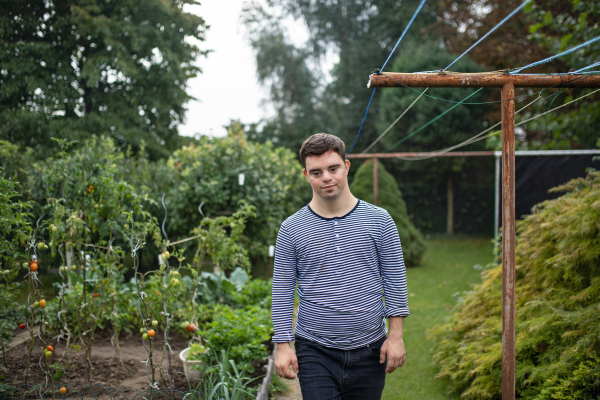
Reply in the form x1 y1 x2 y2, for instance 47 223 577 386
271 225 298 379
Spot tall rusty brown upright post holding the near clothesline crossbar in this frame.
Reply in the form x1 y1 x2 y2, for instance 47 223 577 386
502 82 516 400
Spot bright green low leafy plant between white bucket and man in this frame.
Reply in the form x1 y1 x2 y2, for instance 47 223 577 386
200 306 273 371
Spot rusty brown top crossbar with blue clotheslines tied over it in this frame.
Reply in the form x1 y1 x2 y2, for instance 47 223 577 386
367 72 600 88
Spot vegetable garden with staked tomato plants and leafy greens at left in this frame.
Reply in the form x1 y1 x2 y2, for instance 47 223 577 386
0 131 300 398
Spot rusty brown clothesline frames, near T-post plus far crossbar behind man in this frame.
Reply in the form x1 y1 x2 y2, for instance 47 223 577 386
348 72 600 400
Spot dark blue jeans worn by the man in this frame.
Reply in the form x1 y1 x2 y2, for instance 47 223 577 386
294 336 387 400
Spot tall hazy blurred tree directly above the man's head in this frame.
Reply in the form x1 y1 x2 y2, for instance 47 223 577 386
245 0 434 151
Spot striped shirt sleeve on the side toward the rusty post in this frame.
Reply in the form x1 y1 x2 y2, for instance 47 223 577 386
379 214 410 318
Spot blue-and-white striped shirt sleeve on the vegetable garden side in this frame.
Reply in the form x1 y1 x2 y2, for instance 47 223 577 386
271 225 297 343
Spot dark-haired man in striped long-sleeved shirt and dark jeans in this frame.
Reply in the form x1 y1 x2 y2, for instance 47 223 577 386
273 133 409 400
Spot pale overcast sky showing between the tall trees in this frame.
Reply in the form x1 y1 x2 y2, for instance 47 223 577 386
179 0 308 136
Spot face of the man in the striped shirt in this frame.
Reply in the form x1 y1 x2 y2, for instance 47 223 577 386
304 151 350 199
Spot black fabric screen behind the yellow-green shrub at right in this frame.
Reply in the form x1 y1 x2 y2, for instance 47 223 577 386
498 155 600 226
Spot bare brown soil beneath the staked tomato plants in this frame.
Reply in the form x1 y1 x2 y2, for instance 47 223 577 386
3 331 264 393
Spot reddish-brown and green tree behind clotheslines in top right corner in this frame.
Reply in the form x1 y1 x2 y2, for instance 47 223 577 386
436 0 600 149
